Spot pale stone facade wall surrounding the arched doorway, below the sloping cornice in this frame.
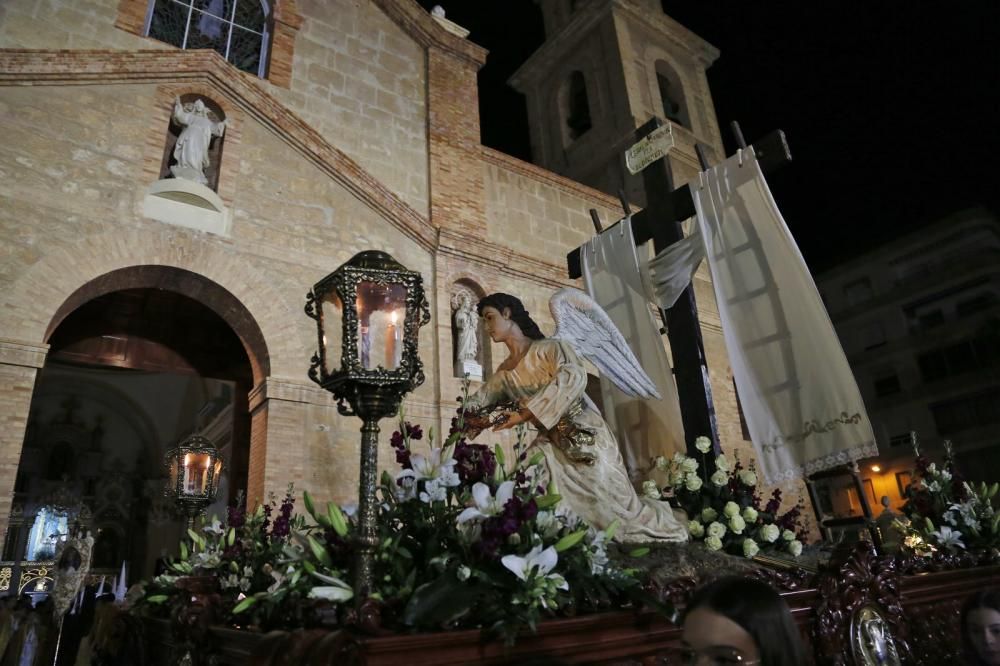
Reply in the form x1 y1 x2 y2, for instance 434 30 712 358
0 78 437 510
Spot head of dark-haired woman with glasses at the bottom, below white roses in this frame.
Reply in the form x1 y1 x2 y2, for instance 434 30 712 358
683 577 805 666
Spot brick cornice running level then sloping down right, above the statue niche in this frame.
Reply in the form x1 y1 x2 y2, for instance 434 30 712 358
0 48 444 250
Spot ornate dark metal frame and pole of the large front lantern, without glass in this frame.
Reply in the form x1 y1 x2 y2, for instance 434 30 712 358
305 250 431 604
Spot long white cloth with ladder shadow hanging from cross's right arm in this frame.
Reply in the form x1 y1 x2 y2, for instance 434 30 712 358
650 149 878 483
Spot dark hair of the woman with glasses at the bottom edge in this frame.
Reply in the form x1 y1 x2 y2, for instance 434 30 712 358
684 576 806 666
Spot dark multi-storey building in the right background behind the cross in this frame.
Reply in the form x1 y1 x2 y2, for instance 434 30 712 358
816 208 1000 506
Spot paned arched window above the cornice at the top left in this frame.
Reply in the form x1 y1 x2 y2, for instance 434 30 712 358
146 0 271 78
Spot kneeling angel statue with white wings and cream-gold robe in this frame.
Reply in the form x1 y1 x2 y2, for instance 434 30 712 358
465 288 688 542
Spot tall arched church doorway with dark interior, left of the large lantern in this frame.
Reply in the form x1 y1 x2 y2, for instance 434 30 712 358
3 266 269 592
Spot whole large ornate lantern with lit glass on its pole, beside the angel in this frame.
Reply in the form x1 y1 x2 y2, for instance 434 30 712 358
305 251 431 604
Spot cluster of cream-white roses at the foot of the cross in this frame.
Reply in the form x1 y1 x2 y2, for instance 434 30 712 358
643 437 805 557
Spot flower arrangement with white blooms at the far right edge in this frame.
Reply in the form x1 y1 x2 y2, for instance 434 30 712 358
895 439 1000 556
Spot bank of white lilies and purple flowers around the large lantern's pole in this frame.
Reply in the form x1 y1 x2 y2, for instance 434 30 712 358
137 386 671 641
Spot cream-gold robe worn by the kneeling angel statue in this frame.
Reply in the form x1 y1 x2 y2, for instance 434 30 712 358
466 338 688 542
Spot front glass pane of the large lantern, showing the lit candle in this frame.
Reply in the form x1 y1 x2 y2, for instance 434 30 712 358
358 282 406 370
